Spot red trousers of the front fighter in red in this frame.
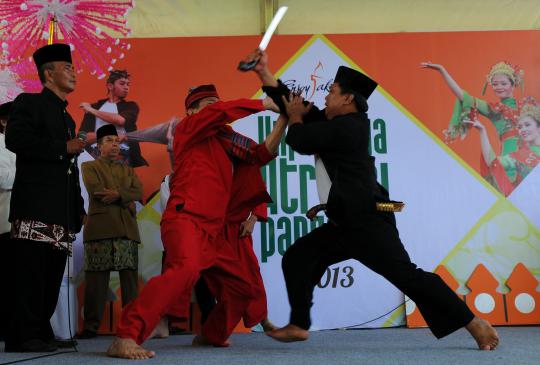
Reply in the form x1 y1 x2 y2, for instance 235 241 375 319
116 216 258 346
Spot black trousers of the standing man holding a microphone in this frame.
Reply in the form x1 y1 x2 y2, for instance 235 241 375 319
6 239 67 347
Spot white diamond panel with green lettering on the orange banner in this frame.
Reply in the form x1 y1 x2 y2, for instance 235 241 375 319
226 37 538 329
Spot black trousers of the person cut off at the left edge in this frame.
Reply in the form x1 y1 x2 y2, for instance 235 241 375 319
0 232 13 341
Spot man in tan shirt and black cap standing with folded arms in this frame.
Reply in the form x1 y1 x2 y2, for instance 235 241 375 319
79 124 142 339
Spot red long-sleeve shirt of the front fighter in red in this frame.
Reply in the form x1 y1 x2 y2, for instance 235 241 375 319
162 99 273 235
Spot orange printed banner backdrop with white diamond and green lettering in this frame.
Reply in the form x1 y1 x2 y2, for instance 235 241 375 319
2 31 540 329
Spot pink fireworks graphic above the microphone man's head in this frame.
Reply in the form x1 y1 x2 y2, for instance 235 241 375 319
0 0 134 79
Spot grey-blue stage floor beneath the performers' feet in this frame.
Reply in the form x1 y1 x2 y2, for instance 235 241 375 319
0 327 540 365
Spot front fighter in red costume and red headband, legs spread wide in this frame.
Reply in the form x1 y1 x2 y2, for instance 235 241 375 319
107 85 286 359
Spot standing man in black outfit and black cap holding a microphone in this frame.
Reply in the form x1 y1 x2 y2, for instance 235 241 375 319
5 44 85 352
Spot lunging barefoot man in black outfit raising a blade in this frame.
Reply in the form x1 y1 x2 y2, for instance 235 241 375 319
247 52 499 350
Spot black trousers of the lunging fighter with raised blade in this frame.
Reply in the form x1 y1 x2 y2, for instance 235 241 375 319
282 213 474 338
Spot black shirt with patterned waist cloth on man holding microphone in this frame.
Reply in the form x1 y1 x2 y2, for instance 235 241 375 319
6 88 84 249
